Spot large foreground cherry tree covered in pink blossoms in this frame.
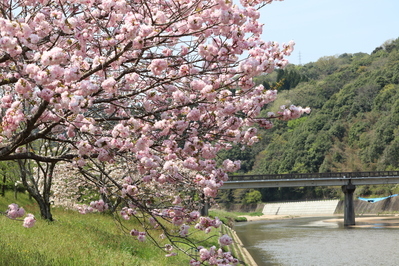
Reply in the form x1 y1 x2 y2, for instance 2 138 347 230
0 0 309 265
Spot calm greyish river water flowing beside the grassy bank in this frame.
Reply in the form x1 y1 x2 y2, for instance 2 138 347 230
234 217 399 266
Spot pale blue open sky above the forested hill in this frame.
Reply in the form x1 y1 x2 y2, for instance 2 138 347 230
260 0 399 64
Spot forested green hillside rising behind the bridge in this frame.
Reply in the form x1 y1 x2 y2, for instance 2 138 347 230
220 38 399 202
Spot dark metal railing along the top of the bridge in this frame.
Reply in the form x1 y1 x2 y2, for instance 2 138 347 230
229 171 399 181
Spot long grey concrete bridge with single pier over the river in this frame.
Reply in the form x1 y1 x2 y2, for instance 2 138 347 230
219 171 399 226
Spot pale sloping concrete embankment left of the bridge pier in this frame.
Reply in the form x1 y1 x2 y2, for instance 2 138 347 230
262 200 339 215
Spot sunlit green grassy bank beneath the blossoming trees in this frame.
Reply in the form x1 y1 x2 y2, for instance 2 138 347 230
0 193 218 266
